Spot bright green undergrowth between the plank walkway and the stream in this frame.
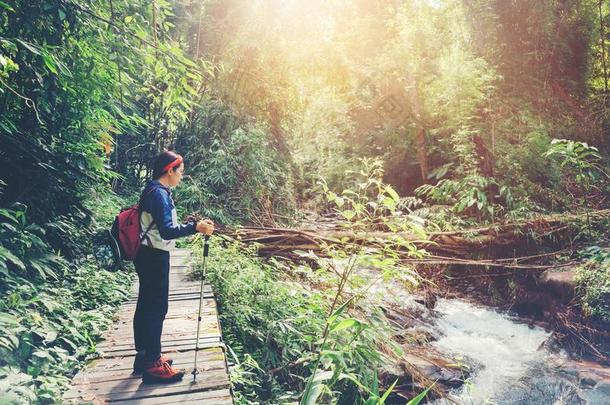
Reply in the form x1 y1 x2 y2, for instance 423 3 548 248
192 238 402 404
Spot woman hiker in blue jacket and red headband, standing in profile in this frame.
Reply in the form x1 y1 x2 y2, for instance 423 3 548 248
133 151 214 383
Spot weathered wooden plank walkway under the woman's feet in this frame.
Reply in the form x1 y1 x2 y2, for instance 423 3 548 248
64 249 233 405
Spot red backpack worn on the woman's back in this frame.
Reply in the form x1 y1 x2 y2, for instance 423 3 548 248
110 187 157 261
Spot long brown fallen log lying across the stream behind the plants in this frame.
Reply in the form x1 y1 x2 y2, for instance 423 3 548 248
225 210 610 269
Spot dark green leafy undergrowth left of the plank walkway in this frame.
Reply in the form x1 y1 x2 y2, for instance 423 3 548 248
0 190 132 404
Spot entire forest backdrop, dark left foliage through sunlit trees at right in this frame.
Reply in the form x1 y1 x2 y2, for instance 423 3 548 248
2 0 610 224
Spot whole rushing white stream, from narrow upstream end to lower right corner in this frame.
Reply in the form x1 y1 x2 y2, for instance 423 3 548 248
335 261 610 405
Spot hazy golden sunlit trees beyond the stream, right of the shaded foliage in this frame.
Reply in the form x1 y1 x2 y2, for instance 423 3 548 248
172 0 609 220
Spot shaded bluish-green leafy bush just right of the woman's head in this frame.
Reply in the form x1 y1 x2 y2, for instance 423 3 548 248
177 101 294 224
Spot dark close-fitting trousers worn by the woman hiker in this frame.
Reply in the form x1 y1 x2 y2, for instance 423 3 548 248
133 246 169 361
